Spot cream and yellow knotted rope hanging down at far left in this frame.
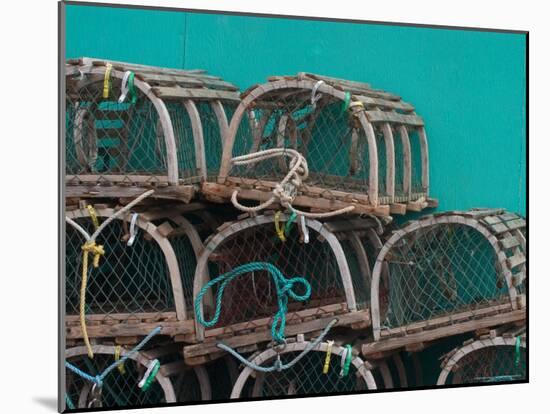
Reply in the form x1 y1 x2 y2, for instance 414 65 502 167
65 190 155 358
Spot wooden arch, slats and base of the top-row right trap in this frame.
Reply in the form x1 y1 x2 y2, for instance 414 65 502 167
203 73 437 215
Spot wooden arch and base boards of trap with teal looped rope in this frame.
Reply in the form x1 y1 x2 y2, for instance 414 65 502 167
184 214 370 365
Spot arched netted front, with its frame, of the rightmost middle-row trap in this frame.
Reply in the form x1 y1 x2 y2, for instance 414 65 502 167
371 210 525 339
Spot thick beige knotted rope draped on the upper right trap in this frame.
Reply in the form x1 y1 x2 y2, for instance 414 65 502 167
231 148 355 218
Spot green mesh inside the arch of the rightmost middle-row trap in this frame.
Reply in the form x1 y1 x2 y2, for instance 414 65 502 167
381 223 510 328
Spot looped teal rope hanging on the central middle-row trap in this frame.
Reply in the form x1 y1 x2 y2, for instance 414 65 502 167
195 262 311 343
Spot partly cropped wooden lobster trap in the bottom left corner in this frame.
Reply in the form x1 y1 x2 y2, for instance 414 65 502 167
65 343 211 408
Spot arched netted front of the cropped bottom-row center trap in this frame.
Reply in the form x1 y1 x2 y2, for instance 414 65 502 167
231 342 376 398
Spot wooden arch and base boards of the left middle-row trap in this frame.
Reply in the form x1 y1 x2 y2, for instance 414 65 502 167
65 207 202 339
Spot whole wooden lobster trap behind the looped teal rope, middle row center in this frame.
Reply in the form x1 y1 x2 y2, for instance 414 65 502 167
184 213 376 364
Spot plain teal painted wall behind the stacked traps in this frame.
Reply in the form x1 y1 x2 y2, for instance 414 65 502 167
66 5 526 214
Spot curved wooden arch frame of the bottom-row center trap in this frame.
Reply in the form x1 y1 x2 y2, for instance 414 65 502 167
231 341 377 399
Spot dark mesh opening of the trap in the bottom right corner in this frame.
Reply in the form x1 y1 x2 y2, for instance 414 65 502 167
446 346 527 384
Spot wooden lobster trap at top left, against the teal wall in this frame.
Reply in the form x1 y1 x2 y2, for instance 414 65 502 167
65 58 239 201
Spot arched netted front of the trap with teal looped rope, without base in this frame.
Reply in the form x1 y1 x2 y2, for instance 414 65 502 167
194 214 358 333
